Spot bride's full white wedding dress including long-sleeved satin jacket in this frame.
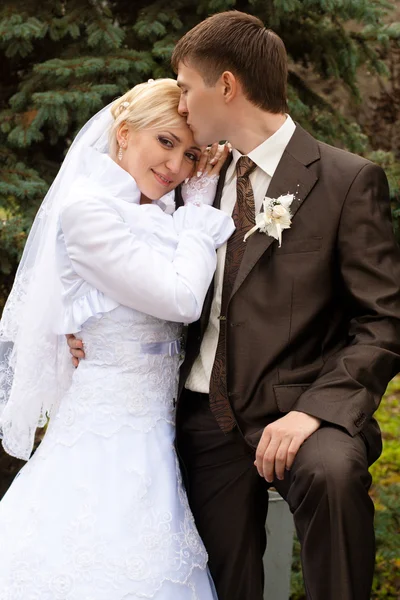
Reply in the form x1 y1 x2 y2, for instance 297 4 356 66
0 148 232 600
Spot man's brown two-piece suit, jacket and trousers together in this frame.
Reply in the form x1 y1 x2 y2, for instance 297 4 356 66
177 126 400 600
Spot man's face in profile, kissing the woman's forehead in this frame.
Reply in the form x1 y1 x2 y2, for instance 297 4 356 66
177 62 227 146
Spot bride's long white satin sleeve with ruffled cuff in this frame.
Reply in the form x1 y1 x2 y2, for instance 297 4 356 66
61 198 234 323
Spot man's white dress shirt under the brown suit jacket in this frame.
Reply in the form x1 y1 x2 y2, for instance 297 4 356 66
186 115 296 394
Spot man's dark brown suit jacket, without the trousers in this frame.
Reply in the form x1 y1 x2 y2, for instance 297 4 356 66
180 126 400 460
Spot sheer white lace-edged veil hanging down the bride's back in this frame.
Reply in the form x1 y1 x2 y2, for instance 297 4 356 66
0 105 113 460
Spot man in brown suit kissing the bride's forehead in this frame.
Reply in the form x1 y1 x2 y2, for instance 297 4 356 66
172 11 400 600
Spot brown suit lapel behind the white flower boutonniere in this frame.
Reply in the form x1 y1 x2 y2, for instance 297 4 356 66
231 126 319 297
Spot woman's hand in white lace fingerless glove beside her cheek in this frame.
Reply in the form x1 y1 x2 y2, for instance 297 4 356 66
182 143 231 206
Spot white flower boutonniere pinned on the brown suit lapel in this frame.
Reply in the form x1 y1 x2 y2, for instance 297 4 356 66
244 194 294 247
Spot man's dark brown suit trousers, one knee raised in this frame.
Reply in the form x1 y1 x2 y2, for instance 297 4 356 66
177 390 375 600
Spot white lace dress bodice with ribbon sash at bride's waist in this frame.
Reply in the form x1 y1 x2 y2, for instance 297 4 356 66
47 306 182 445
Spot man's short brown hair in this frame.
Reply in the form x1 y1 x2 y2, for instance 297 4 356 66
172 10 287 113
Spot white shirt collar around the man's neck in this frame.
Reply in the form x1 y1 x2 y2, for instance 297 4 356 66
225 115 296 183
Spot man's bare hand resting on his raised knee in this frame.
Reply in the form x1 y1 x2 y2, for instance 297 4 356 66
254 410 321 483
